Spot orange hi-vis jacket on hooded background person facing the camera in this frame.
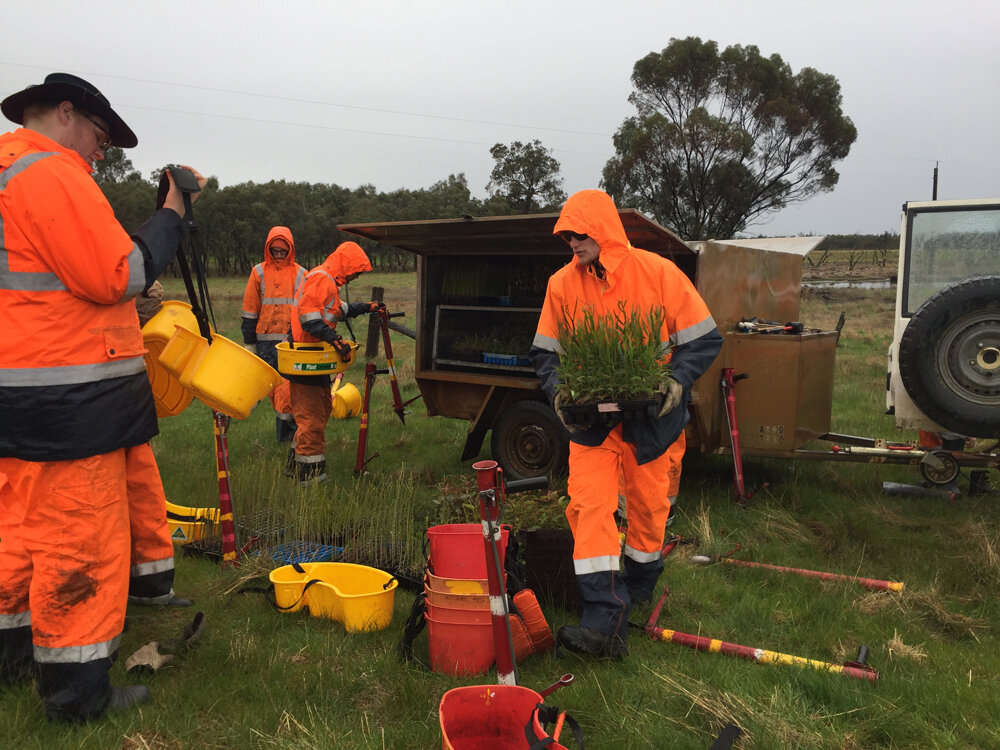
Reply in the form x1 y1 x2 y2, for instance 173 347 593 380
242 227 306 344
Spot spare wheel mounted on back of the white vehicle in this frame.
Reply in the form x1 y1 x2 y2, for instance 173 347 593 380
899 276 1000 438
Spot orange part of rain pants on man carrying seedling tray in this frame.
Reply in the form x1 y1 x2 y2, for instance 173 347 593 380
566 425 683 575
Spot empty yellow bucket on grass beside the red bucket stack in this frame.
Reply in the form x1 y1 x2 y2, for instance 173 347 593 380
269 563 399 632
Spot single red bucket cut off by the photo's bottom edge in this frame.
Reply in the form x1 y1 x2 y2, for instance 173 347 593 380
438 685 565 750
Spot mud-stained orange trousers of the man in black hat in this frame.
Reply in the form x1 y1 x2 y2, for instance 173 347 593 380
0 449 129 721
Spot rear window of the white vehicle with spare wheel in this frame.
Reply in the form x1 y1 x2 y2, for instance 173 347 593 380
903 206 1000 315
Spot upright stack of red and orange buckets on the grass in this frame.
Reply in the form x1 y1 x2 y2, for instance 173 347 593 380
424 523 510 677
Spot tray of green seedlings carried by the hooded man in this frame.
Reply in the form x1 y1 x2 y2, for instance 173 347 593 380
556 300 670 424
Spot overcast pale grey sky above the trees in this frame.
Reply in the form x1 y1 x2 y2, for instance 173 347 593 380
0 0 1000 235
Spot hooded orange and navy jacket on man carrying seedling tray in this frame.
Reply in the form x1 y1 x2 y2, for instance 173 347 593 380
530 190 722 464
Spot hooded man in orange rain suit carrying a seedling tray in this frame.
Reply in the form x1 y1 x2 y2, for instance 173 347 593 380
530 190 722 657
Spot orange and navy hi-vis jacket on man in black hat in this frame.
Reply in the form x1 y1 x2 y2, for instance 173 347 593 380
0 128 184 461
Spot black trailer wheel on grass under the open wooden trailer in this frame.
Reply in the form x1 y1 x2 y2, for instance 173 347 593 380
490 400 569 479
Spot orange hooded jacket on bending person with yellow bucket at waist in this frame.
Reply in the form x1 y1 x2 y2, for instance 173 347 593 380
292 242 372 343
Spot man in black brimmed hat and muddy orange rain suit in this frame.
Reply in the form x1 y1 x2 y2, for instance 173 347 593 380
0 73 205 721
